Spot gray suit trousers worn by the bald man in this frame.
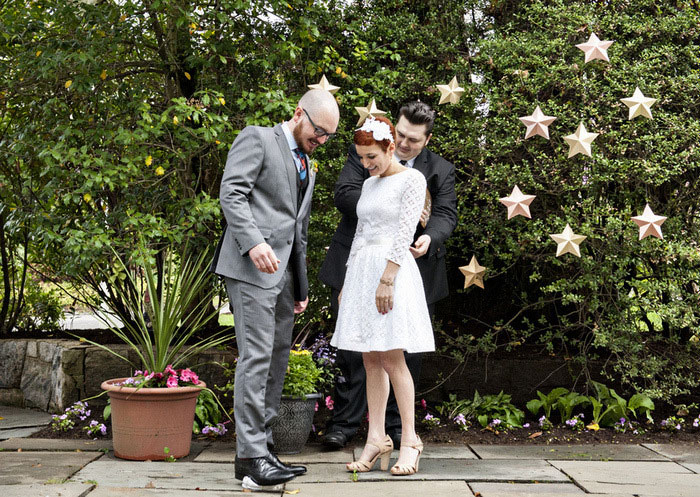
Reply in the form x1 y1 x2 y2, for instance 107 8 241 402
225 267 294 457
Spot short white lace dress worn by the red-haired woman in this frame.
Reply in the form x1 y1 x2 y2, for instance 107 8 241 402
331 169 435 352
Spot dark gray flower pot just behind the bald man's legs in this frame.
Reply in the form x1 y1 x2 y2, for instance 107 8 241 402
272 393 322 454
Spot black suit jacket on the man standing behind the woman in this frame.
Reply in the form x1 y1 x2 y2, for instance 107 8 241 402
319 145 457 304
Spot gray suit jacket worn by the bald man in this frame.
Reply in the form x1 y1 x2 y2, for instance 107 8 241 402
211 124 316 301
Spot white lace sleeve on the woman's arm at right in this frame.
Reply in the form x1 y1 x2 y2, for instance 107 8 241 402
388 171 426 266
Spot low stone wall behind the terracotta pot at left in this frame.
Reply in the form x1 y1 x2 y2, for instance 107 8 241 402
0 339 233 412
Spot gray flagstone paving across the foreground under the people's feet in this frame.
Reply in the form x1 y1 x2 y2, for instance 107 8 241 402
0 407 700 497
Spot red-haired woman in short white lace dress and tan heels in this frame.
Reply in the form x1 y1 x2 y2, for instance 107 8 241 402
331 117 435 476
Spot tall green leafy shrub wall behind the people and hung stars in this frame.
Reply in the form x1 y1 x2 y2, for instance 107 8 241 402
0 0 700 399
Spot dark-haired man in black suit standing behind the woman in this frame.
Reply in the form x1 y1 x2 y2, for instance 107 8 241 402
319 102 457 448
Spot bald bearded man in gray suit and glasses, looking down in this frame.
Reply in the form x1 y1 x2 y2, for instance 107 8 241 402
212 90 339 490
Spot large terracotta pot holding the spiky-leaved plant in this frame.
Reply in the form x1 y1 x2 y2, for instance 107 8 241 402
101 378 206 461
